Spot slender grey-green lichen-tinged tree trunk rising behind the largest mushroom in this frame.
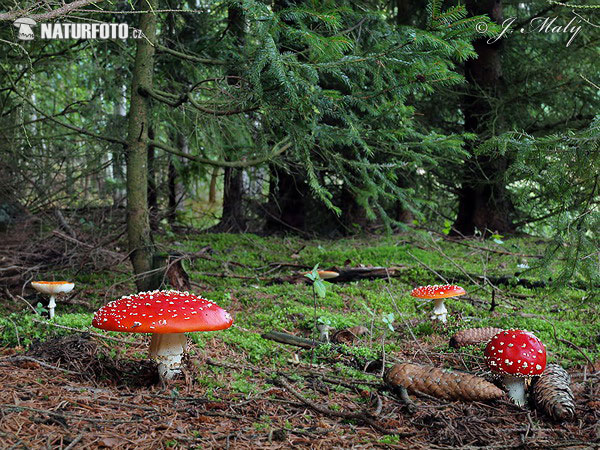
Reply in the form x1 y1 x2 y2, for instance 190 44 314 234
127 0 158 291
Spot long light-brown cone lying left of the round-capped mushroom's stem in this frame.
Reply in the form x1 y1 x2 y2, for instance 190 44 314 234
384 363 504 401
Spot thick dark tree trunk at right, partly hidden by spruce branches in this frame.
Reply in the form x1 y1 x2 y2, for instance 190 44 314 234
453 0 514 235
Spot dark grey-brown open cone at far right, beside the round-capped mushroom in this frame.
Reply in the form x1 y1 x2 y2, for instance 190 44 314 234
533 364 575 420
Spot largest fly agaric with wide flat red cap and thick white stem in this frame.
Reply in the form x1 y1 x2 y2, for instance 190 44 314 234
92 291 233 380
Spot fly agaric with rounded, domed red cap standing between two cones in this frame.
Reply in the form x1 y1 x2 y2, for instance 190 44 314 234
485 330 546 406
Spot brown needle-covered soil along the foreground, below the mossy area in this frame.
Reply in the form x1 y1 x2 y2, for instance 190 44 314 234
0 334 600 449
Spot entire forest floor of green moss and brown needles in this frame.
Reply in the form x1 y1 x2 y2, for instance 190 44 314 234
0 227 600 449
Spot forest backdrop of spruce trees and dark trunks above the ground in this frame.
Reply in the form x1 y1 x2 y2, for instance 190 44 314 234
0 0 600 289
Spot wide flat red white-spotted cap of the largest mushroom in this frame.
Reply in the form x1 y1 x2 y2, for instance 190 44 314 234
92 291 233 334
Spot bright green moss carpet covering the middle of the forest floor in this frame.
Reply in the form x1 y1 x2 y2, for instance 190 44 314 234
0 232 600 370
